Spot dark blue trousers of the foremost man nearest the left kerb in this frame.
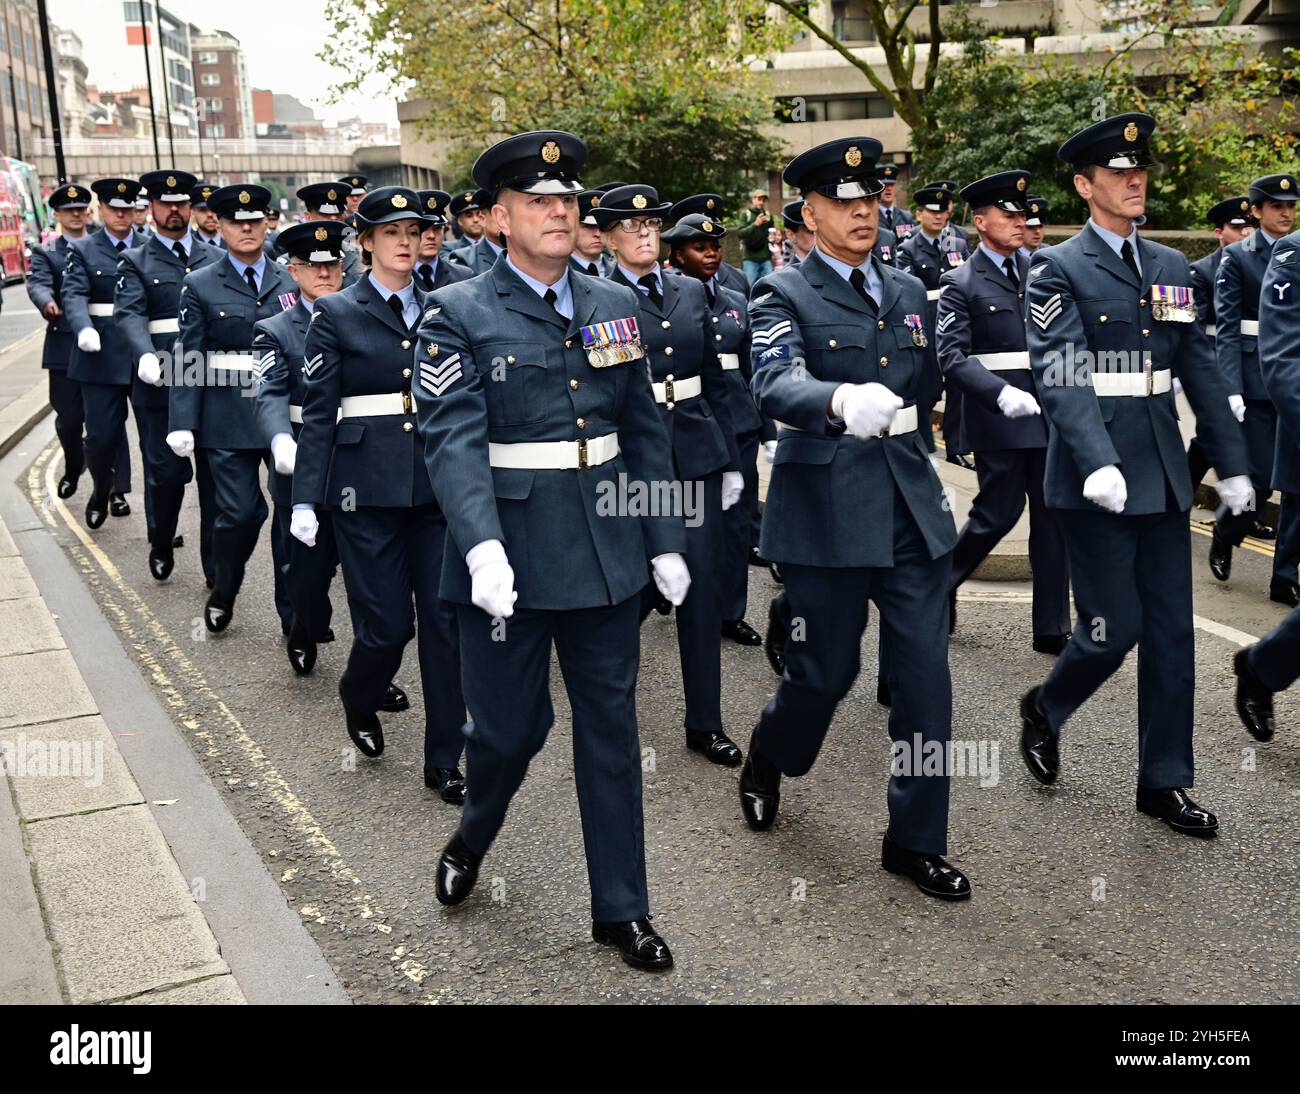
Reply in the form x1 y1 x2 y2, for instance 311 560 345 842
454 587 647 922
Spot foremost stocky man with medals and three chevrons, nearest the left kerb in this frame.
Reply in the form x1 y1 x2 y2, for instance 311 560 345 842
416 131 686 969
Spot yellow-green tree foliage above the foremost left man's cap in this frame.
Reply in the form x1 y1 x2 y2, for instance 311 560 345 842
324 0 789 205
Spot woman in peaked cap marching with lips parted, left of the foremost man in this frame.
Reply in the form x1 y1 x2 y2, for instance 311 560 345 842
290 186 465 804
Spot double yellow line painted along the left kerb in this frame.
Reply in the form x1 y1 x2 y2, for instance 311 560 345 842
27 442 432 999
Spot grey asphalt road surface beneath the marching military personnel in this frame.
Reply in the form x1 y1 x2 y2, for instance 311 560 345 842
12 413 1300 1003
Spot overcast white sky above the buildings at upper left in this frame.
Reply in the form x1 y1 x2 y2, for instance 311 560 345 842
49 0 397 125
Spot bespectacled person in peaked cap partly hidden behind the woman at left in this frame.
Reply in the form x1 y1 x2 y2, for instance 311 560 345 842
254 221 347 676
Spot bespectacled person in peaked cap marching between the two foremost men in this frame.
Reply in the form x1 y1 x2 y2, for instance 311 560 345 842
595 183 745 767
